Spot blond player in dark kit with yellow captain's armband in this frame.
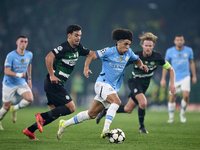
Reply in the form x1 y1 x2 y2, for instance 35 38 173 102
96 32 175 134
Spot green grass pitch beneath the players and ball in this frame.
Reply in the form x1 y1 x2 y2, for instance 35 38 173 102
0 107 200 150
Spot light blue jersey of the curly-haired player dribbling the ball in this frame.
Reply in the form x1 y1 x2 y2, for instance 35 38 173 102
96 46 139 92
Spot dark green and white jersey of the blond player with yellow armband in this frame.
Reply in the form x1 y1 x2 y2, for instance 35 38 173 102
130 51 171 86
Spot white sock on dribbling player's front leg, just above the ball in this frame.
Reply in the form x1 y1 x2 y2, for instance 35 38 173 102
103 103 119 131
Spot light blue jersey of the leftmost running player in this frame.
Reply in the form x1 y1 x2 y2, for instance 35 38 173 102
2 50 33 87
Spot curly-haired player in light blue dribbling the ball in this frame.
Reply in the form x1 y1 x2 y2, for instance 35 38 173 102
57 29 148 140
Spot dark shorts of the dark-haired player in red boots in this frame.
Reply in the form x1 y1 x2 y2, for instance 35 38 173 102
44 76 72 107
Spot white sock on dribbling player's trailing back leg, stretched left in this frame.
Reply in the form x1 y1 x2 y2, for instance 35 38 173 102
64 110 90 127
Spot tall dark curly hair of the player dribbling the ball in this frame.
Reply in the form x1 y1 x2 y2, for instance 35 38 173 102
112 28 133 41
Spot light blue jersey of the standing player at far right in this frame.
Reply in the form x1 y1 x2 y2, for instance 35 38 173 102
165 46 194 82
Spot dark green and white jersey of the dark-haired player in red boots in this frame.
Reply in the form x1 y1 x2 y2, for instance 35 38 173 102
52 41 90 85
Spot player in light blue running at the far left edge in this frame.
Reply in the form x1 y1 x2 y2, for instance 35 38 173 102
0 36 33 130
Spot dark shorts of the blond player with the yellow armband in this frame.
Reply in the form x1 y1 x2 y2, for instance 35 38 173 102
128 78 149 105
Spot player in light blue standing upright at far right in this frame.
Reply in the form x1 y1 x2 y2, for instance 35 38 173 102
161 35 197 123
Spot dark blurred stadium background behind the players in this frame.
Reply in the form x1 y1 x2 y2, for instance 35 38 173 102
0 0 200 110
